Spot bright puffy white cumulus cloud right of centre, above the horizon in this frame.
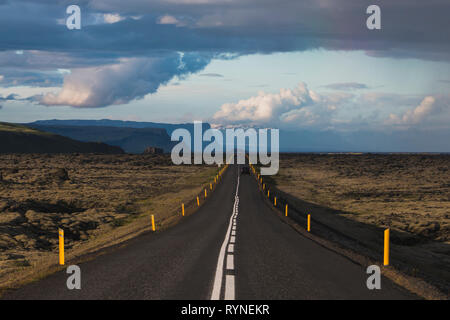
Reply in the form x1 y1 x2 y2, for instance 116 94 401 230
212 82 353 127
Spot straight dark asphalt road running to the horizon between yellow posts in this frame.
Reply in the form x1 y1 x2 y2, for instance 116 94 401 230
3 166 414 300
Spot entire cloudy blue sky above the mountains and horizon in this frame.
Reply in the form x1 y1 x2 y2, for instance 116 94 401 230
0 0 450 151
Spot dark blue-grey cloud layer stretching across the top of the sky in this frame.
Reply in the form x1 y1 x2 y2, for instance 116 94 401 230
0 0 450 60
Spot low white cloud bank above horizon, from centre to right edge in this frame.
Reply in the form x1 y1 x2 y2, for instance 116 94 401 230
210 82 450 131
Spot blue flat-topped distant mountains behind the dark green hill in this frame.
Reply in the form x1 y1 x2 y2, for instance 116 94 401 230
25 119 211 153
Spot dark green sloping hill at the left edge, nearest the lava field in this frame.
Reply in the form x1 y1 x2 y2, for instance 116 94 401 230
0 122 124 154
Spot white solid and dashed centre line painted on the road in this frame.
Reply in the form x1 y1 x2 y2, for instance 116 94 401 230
211 171 240 300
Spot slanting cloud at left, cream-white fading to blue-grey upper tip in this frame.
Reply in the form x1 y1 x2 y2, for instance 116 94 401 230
36 53 210 108
